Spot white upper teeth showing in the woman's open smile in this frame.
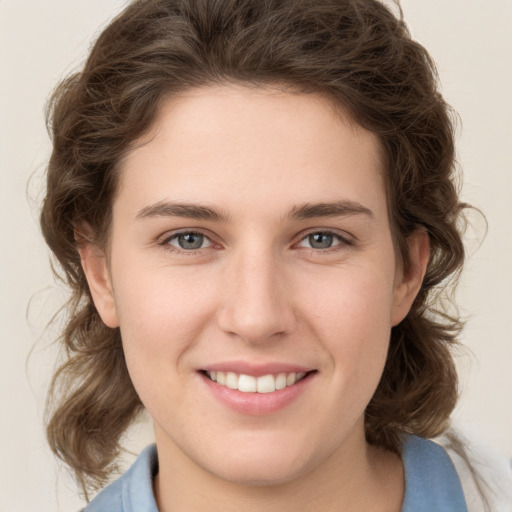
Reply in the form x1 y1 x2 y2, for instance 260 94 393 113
201 371 313 393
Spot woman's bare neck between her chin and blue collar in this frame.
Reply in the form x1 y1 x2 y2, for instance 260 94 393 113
154 424 404 512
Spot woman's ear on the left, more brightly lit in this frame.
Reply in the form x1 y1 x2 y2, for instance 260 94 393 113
79 242 119 328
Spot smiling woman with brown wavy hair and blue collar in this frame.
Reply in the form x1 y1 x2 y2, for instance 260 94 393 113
41 0 512 512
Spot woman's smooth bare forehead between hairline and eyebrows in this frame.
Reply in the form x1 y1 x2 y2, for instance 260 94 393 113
119 85 385 219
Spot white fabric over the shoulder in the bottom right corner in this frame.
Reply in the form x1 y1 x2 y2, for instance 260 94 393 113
435 432 512 512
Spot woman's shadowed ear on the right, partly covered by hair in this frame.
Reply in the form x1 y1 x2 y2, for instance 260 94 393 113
391 229 430 326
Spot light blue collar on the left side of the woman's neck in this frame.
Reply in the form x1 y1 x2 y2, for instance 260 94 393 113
83 445 158 512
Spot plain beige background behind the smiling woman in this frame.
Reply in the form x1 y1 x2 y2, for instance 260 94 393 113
0 0 512 512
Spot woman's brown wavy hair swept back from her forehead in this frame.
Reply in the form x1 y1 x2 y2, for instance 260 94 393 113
41 0 465 492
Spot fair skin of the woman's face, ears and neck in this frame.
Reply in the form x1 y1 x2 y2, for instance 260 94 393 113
82 85 428 512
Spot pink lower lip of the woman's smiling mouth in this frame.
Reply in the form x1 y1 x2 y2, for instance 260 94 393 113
199 372 314 416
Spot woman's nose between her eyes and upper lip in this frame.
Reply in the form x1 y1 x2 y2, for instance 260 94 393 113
218 244 296 345
